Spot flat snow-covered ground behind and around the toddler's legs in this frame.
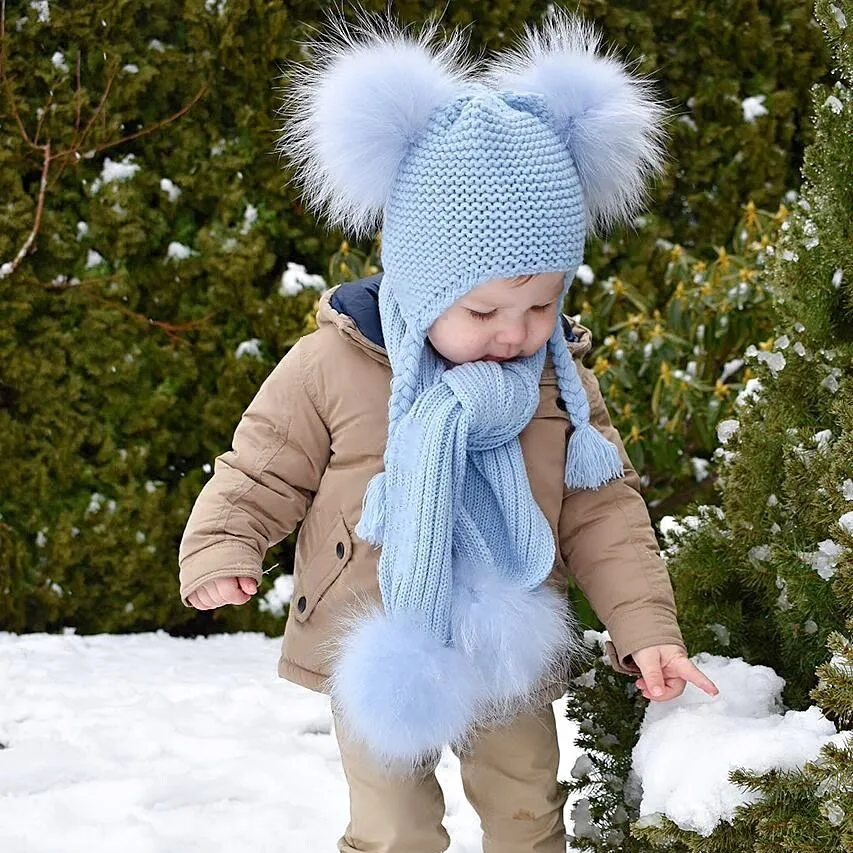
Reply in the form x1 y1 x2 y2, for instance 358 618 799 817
0 633 579 853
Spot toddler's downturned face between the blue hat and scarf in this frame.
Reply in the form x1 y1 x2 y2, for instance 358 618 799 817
427 272 564 364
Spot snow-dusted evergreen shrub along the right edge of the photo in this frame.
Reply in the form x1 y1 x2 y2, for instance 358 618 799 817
574 0 853 853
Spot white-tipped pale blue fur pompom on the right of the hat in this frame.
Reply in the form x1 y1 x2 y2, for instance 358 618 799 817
485 8 668 233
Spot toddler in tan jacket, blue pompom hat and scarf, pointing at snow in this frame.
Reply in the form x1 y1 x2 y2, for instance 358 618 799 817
180 10 716 853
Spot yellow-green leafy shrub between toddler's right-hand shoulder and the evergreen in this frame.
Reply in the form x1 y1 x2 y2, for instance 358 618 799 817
580 202 788 518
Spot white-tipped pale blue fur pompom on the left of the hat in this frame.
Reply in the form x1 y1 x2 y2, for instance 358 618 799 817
276 8 473 237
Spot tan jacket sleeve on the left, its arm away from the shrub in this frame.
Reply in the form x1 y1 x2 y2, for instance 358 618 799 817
178 339 330 604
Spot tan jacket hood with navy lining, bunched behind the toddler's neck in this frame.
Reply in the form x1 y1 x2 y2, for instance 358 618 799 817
317 273 592 366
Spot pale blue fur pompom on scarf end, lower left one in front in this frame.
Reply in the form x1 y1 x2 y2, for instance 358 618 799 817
330 609 480 773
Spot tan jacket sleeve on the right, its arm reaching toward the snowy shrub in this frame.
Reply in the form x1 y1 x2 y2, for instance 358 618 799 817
559 360 684 673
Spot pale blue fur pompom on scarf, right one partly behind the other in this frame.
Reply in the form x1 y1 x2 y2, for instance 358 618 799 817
452 564 582 723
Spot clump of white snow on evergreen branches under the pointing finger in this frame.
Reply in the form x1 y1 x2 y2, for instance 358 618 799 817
633 653 842 836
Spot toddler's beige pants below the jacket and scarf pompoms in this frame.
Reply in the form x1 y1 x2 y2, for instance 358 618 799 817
336 704 566 853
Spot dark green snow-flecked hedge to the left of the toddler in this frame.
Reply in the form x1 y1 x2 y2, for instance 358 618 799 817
0 0 560 632
